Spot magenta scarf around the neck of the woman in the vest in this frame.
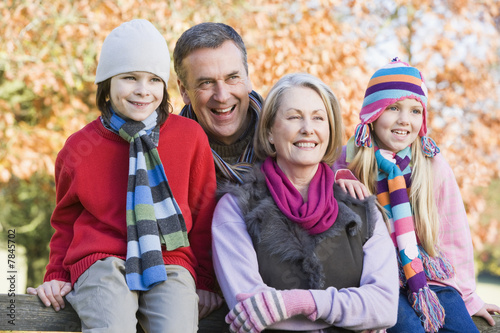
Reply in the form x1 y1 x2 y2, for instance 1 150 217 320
261 157 338 235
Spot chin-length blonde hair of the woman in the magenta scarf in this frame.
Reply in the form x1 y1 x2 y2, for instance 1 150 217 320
254 73 344 166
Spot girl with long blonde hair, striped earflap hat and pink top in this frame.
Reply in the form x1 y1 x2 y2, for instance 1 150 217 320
334 58 500 332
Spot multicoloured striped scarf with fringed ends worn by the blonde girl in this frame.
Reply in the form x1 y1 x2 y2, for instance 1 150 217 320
375 147 453 332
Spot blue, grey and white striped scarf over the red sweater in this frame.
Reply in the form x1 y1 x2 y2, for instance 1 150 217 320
103 107 189 290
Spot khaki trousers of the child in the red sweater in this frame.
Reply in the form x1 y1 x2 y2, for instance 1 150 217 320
66 257 198 333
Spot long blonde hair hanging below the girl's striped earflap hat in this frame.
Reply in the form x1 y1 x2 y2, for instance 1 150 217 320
348 137 439 257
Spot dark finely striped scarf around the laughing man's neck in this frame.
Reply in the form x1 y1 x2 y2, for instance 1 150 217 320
180 90 262 184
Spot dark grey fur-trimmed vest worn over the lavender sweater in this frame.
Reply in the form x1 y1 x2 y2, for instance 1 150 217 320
220 165 377 333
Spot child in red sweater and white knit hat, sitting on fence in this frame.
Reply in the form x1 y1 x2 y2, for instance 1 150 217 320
28 20 221 332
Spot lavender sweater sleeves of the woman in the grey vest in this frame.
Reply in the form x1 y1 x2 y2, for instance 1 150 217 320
212 194 399 331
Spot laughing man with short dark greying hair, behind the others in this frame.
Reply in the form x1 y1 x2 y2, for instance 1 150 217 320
174 22 262 184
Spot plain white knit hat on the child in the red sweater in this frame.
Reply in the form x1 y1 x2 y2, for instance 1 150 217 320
95 20 170 86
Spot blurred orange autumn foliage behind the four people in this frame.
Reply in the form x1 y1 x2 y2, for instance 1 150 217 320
0 0 500 285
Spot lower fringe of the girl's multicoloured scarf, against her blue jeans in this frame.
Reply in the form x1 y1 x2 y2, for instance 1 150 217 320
408 286 445 333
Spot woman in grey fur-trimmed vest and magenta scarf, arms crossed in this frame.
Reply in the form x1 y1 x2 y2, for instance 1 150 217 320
212 74 398 332
